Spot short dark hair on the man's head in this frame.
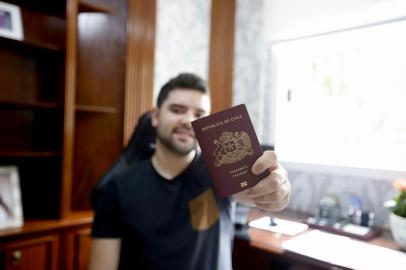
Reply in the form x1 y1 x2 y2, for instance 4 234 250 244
156 73 208 108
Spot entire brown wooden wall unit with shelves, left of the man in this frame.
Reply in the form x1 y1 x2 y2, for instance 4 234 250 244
0 0 151 270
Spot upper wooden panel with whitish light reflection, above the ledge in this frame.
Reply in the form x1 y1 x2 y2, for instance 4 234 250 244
76 4 127 108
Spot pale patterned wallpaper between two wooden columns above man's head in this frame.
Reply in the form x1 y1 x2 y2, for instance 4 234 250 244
154 0 211 102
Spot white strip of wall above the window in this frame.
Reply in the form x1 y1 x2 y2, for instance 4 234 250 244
265 0 406 42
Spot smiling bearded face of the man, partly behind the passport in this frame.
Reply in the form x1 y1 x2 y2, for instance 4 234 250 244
152 88 210 156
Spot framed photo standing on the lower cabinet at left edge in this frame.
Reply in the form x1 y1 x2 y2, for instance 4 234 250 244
0 166 23 230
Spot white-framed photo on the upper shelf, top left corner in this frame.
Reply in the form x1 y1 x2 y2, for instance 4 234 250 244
0 1 24 40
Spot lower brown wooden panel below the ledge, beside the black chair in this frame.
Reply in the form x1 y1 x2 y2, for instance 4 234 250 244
72 112 122 211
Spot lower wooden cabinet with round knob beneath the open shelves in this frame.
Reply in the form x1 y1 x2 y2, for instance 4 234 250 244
0 212 92 270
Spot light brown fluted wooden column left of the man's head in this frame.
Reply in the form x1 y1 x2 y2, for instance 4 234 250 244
123 0 156 145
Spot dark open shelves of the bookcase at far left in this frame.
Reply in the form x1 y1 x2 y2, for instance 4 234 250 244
0 1 66 219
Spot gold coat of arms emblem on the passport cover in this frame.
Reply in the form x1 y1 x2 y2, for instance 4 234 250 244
213 131 254 167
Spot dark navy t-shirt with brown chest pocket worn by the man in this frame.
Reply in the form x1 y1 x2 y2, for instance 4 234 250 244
92 154 235 270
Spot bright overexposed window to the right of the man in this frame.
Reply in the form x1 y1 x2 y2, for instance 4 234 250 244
272 22 406 172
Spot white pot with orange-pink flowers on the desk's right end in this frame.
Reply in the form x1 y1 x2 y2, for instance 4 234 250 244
385 178 406 250
